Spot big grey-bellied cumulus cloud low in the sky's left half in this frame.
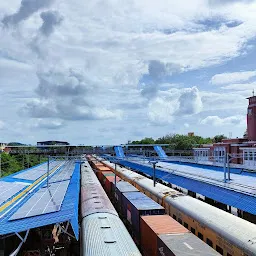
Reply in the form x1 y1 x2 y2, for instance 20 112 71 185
22 70 122 120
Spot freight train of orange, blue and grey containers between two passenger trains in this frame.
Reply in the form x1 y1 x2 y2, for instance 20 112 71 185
88 156 219 256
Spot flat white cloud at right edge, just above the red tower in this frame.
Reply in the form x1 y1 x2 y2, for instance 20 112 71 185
210 71 256 85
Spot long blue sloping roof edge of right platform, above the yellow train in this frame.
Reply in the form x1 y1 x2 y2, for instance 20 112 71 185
115 160 256 214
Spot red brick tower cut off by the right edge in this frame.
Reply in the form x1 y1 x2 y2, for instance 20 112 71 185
247 91 256 141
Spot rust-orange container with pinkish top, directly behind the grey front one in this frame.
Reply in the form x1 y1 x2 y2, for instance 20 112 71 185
140 215 190 256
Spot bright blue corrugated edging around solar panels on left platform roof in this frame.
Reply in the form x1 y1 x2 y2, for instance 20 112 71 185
0 163 80 239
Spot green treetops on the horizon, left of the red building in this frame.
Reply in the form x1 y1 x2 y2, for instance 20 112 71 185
131 134 226 150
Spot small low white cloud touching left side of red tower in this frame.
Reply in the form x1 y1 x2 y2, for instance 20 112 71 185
200 115 246 126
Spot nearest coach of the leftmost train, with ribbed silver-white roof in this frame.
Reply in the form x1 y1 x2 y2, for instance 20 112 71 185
81 213 141 256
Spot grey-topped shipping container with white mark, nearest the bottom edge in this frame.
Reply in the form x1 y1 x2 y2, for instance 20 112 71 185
157 233 220 256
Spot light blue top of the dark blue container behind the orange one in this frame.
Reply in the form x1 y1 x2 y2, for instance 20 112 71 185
123 192 164 210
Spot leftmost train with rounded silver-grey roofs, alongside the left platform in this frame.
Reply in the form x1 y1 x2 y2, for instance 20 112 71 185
80 161 141 256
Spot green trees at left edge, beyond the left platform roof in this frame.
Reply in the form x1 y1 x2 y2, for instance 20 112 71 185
0 153 47 177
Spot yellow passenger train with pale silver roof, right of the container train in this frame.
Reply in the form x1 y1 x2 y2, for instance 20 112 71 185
91 157 256 256
